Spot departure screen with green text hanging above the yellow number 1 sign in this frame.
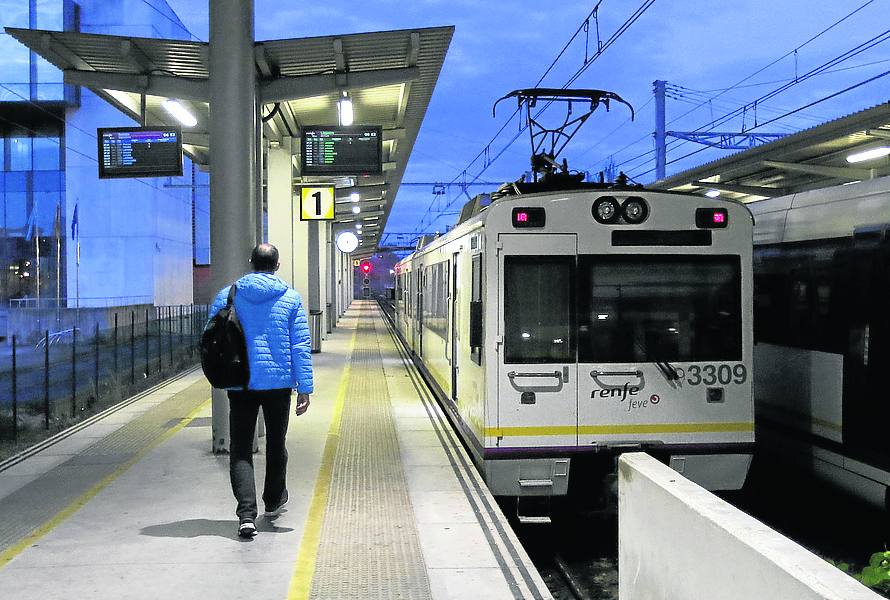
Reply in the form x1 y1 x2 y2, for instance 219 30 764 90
300 125 383 175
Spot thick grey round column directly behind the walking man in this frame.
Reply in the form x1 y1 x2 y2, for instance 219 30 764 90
210 0 258 452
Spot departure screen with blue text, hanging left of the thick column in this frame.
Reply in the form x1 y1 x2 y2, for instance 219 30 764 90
96 126 182 179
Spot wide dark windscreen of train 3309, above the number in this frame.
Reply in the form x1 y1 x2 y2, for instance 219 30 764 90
578 255 742 363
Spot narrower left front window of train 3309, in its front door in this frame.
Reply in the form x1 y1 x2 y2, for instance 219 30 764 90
504 256 575 363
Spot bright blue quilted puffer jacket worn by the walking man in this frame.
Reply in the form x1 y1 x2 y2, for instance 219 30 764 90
210 273 312 394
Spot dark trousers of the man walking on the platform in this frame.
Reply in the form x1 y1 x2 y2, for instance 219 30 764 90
228 389 291 520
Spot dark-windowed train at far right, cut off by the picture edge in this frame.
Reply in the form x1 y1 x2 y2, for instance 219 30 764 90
748 178 890 508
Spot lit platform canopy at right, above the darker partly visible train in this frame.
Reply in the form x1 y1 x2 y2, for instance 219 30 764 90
650 102 890 202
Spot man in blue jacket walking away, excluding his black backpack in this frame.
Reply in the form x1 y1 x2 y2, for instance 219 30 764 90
210 244 312 538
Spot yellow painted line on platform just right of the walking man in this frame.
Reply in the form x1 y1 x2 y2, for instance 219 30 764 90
287 328 358 600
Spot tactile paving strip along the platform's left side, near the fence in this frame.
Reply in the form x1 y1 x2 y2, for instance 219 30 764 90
0 382 210 569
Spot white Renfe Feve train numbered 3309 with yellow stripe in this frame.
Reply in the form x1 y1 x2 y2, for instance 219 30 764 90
395 184 754 497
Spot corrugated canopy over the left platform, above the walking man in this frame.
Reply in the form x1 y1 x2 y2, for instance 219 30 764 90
6 27 454 252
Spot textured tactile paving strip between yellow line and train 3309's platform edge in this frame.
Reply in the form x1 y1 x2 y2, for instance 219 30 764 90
311 306 432 600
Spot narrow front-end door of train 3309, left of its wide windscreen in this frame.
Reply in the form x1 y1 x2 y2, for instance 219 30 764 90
493 234 578 447
